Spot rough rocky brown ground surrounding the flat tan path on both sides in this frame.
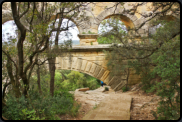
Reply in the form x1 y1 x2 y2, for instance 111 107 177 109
60 84 159 120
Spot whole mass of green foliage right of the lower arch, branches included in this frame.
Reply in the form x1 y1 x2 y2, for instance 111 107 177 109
98 12 180 120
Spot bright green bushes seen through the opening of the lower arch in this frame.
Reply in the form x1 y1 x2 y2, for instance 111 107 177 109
55 69 100 91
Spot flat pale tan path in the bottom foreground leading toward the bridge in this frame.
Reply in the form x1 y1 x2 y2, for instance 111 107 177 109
83 93 132 120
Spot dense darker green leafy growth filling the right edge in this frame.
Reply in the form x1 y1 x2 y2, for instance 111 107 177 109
136 20 180 120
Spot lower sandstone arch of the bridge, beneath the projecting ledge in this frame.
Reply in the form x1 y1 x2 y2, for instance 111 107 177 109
56 52 129 91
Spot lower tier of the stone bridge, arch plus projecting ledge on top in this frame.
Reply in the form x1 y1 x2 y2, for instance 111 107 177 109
56 44 140 91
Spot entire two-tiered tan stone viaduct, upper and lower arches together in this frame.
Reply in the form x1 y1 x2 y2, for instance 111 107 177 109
2 2 177 90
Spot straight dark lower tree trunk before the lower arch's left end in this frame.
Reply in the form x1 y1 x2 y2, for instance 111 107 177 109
48 58 56 96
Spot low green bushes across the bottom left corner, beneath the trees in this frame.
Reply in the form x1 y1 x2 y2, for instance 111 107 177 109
3 86 80 120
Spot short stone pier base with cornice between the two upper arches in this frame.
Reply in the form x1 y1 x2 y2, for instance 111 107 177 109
78 34 98 45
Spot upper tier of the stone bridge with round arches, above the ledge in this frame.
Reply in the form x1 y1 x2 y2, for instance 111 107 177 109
2 2 159 45
